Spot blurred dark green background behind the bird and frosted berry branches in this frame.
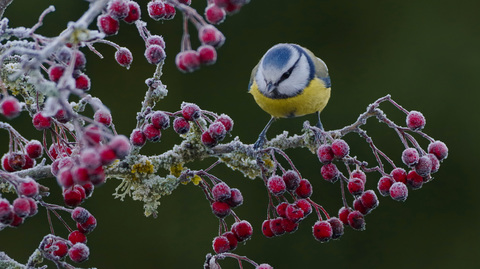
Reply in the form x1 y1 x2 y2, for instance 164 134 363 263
0 0 480 269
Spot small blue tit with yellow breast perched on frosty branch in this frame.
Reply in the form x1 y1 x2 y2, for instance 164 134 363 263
248 43 331 149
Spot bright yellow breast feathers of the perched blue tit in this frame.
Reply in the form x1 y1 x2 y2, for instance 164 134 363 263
249 78 330 118
